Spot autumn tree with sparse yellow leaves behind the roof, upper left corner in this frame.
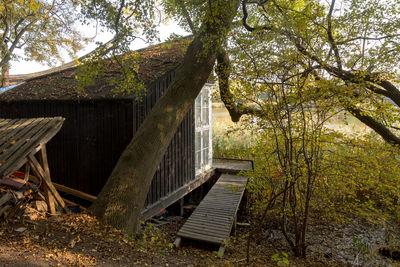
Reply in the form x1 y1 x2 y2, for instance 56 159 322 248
0 0 85 85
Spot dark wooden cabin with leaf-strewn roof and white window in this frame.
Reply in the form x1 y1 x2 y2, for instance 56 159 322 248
0 40 211 217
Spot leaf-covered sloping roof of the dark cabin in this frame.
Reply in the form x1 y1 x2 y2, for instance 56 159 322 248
0 40 188 101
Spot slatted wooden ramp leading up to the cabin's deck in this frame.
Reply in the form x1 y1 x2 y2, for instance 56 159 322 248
174 174 247 256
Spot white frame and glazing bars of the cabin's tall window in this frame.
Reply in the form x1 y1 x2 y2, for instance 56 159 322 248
194 83 214 175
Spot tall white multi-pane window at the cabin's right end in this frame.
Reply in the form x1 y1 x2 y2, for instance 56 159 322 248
195 84 212 174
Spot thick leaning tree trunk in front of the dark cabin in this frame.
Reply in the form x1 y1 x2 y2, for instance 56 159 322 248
90 0 240 233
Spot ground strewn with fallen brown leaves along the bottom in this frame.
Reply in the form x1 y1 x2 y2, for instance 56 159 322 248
0 213 395 266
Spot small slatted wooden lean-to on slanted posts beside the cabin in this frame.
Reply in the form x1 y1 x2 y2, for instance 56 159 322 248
0 117 68 214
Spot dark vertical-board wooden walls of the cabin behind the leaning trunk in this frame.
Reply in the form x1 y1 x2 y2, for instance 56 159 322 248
0 73 195 209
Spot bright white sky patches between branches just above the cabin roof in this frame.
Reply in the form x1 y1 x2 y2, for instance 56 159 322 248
10 21 189 75
